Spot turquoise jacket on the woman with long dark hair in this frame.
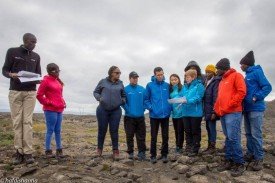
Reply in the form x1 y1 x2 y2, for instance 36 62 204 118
170 85 183 118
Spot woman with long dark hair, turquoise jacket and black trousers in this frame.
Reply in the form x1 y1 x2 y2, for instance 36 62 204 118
170 74 184 153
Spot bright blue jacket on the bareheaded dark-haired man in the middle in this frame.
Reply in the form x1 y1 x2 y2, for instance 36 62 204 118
145 76 172 118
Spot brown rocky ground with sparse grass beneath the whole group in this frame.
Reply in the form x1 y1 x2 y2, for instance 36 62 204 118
0 113 275 183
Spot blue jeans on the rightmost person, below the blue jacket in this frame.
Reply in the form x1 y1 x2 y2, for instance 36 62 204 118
244 112 264 160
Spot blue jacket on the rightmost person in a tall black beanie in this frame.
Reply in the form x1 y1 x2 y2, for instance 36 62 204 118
244 65 272 112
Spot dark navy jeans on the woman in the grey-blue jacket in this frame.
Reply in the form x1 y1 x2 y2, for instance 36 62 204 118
96 106 122 150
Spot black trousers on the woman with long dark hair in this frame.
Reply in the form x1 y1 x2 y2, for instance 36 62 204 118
172 118 184 149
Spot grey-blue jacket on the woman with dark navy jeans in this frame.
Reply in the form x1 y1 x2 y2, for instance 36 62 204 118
94 77 126 111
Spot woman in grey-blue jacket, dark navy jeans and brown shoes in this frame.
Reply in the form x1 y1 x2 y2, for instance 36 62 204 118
94 66 126 159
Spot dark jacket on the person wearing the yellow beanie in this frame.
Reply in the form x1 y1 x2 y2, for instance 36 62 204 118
204 76 222 121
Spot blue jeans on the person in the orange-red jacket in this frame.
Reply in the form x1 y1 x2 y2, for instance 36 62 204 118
221 112 244 164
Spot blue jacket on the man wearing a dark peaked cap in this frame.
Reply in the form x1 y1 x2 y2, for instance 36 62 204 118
123 84 145 118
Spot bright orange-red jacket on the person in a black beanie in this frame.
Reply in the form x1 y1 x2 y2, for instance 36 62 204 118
214 68 246 116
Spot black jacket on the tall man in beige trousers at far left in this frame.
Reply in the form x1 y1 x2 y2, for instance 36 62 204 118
2 46 41 91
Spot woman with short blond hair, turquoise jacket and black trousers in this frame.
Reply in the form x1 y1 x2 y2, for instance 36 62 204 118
182 69 205 157
